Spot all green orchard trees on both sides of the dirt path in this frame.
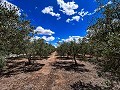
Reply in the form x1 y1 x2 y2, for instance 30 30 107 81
0 0 120 78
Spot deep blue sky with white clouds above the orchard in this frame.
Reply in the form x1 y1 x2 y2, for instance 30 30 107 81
0 0 111 45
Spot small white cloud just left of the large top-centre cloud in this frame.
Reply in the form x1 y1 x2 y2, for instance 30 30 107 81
42 6 60 19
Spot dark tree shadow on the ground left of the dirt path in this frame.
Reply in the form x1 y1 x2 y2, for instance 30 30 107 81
0 60 44 77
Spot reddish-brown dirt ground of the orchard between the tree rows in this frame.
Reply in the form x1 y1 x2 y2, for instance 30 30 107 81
0 52 120 90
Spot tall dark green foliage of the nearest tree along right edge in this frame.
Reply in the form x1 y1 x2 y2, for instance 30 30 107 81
88 0 120 75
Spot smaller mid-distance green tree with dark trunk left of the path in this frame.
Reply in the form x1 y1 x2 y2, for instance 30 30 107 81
24 39 55 64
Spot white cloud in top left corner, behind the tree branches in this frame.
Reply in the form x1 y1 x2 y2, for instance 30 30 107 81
0 0 21 16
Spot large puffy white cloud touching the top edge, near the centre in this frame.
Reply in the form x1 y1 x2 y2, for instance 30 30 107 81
57 0 79 16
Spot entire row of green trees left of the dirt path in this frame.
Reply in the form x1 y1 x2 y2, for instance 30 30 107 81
0 3 54 68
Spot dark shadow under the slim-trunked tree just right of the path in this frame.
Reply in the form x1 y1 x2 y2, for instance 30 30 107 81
52 61 89 73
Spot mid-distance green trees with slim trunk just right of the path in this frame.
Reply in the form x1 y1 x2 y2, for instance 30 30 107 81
57 38 89 64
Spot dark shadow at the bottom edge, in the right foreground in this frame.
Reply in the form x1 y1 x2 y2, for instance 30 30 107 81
70 81 104 90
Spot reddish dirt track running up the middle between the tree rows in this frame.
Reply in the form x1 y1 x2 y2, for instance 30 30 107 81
36 52 56 90
